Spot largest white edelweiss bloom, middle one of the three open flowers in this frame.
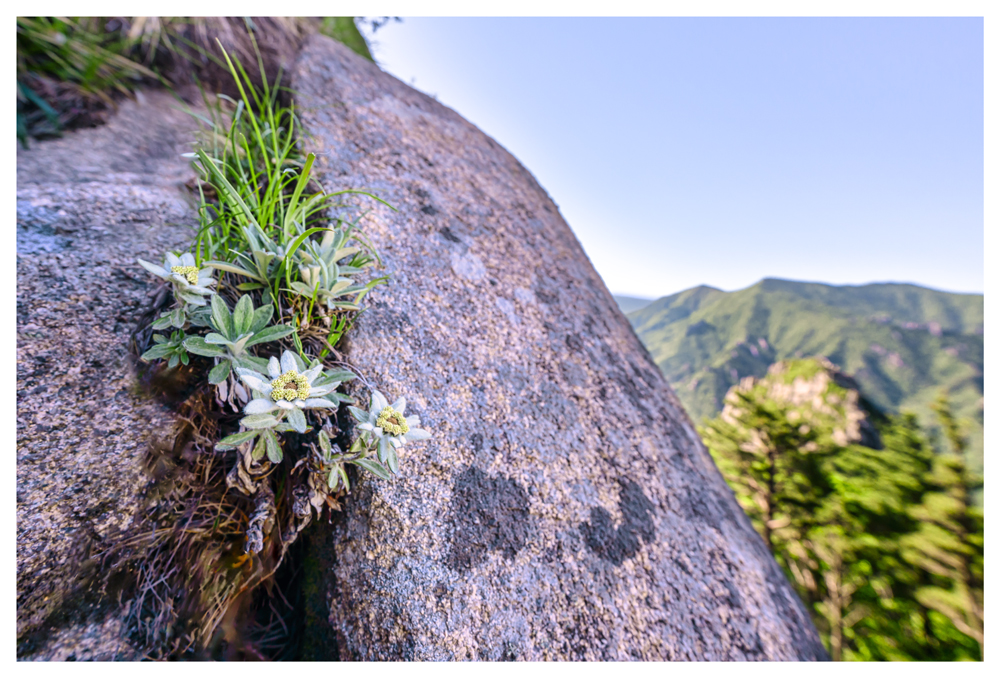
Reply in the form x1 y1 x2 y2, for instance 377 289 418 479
236 351 337 433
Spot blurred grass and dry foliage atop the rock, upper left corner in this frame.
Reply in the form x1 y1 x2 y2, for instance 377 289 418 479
17 17 378 147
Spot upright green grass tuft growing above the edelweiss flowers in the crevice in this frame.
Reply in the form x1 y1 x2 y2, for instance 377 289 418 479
191 43 392 359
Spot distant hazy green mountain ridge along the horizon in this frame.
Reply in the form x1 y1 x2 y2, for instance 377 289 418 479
628 278 984 470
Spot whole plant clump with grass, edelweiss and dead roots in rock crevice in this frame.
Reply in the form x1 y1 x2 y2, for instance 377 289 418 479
105 46 430 657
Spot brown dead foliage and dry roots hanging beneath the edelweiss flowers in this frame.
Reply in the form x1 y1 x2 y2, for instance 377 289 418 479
99 287 342 659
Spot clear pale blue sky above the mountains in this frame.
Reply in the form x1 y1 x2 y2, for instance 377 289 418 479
360 18 984 297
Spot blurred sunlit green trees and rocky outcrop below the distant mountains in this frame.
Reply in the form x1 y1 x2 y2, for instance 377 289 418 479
701 359 983 660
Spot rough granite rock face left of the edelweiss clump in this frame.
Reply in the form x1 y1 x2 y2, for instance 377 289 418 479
17 92 197 659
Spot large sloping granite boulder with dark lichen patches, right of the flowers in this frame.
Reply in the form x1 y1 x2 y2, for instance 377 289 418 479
292 36 826 660
